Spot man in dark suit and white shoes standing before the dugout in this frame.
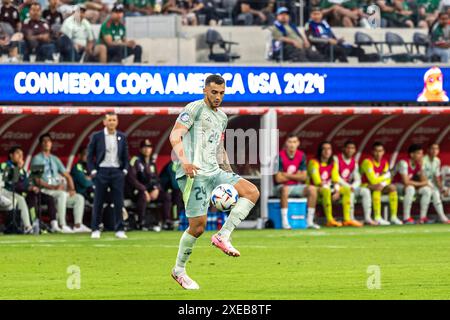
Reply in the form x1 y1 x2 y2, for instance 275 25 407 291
88 112 128 239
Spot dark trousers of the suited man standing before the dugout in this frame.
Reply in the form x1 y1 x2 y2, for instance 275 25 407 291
91 168 125 231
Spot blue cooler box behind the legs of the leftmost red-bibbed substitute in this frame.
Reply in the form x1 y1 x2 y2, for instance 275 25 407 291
268 198 308 229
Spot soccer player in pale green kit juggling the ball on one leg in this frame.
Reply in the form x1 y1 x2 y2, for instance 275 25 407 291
170 75 259 290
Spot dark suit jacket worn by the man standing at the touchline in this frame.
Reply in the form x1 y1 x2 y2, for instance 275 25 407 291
87 130 128 173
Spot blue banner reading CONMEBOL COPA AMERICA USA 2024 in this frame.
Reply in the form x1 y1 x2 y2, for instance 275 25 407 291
0 64 450 104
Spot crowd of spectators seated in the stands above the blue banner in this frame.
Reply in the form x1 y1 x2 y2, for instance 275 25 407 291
0 0 450 63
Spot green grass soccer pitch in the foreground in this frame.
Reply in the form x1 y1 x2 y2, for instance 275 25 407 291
0 225 450 300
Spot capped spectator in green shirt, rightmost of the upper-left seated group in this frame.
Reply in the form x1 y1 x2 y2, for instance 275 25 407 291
98 3 142 63
